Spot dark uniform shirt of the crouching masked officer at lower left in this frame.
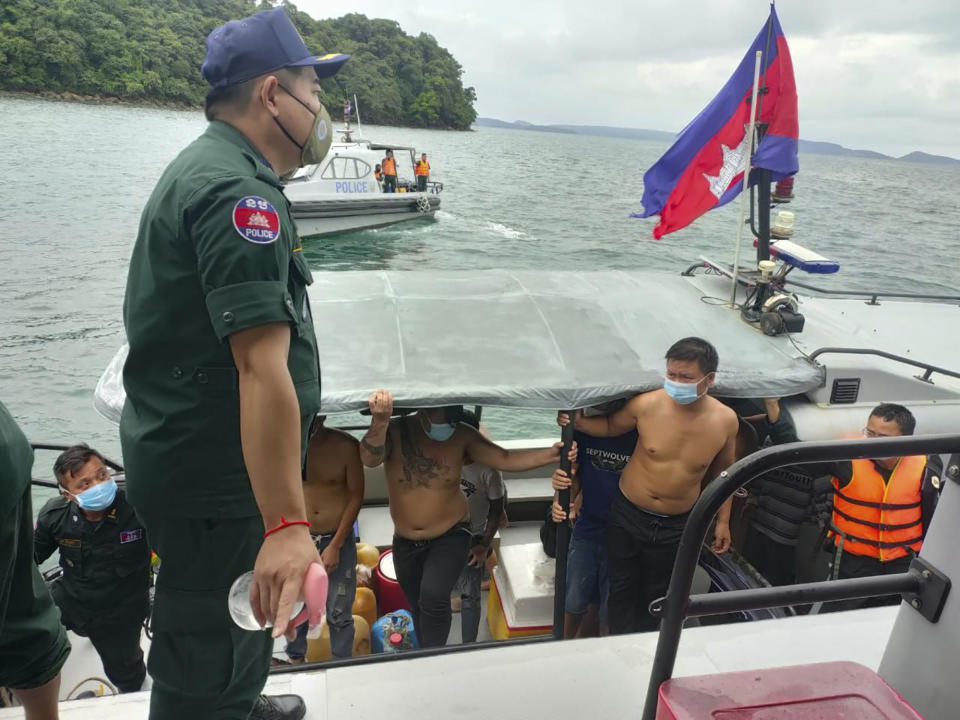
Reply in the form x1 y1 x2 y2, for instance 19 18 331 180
33 490 150 627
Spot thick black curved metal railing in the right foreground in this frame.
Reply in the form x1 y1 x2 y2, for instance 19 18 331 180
643 435 960 720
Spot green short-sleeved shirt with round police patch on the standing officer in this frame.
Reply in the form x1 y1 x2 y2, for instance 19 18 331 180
120 122 320 518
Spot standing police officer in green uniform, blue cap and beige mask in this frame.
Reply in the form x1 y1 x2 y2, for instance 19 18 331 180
120 8 348 720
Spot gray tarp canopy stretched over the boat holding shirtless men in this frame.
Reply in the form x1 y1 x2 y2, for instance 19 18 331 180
97 270 823 419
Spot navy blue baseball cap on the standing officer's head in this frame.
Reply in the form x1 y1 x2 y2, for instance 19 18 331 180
200 7 350 89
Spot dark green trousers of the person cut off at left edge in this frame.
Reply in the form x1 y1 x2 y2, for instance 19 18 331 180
0 485 70 690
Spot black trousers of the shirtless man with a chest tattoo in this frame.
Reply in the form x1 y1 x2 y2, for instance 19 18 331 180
393 523 472 647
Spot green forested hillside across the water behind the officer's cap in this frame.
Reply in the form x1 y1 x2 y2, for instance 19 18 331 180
0 0 476 129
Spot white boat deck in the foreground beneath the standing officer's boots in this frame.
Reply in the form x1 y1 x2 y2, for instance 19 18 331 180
0 607 897 720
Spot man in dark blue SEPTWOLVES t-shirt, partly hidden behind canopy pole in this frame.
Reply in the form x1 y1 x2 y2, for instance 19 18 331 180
553 402 637 638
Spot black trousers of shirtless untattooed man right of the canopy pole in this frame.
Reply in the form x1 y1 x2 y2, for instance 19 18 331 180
607 492 689 635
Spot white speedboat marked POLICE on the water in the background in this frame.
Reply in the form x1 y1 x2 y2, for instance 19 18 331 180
284 125 443 238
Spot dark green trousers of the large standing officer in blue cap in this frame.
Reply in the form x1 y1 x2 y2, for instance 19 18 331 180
136 507 273 720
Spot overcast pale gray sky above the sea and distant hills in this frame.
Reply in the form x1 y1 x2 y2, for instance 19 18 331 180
296 0 960 157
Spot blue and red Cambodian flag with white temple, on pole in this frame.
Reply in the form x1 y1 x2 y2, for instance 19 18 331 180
631 5 799 240
